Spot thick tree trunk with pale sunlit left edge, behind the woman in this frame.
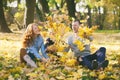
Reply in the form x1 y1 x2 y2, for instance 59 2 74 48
24 0 36 27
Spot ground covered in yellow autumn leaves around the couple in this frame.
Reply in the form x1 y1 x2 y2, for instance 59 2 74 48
0 33 120 80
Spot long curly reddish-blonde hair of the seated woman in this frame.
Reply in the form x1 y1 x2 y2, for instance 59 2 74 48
22 23 38 48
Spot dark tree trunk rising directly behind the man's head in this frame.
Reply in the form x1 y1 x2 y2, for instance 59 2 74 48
66 0 75 18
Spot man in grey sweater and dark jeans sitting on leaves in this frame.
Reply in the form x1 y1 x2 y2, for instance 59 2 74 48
67 20 109 70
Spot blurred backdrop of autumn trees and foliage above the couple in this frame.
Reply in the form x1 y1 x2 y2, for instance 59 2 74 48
0 0 120 32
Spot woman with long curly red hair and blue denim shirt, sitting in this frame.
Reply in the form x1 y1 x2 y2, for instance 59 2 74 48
20 23 49 67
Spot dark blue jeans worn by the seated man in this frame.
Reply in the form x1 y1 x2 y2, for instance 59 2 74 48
81 47 106 70
